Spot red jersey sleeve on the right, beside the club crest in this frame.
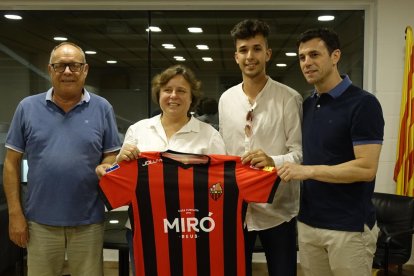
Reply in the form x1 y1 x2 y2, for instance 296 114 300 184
236 163 280 203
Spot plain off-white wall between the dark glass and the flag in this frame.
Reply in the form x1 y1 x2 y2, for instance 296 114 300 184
374 0 414 264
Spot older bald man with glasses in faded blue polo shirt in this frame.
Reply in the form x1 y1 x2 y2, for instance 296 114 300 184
4 42 120 276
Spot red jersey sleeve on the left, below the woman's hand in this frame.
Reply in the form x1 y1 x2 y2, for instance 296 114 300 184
99 161 138 210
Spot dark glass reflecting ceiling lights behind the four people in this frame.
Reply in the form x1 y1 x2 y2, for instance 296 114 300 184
0 10 364 135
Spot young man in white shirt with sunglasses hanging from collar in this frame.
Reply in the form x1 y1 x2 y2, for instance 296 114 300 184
219 19 302 276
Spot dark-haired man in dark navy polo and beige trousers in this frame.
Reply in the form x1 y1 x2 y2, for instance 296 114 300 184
278 28 384 276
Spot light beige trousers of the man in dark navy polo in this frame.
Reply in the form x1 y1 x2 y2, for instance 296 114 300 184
298 222 379 276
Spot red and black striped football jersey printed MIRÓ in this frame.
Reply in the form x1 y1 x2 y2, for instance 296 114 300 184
99 151 280 276
